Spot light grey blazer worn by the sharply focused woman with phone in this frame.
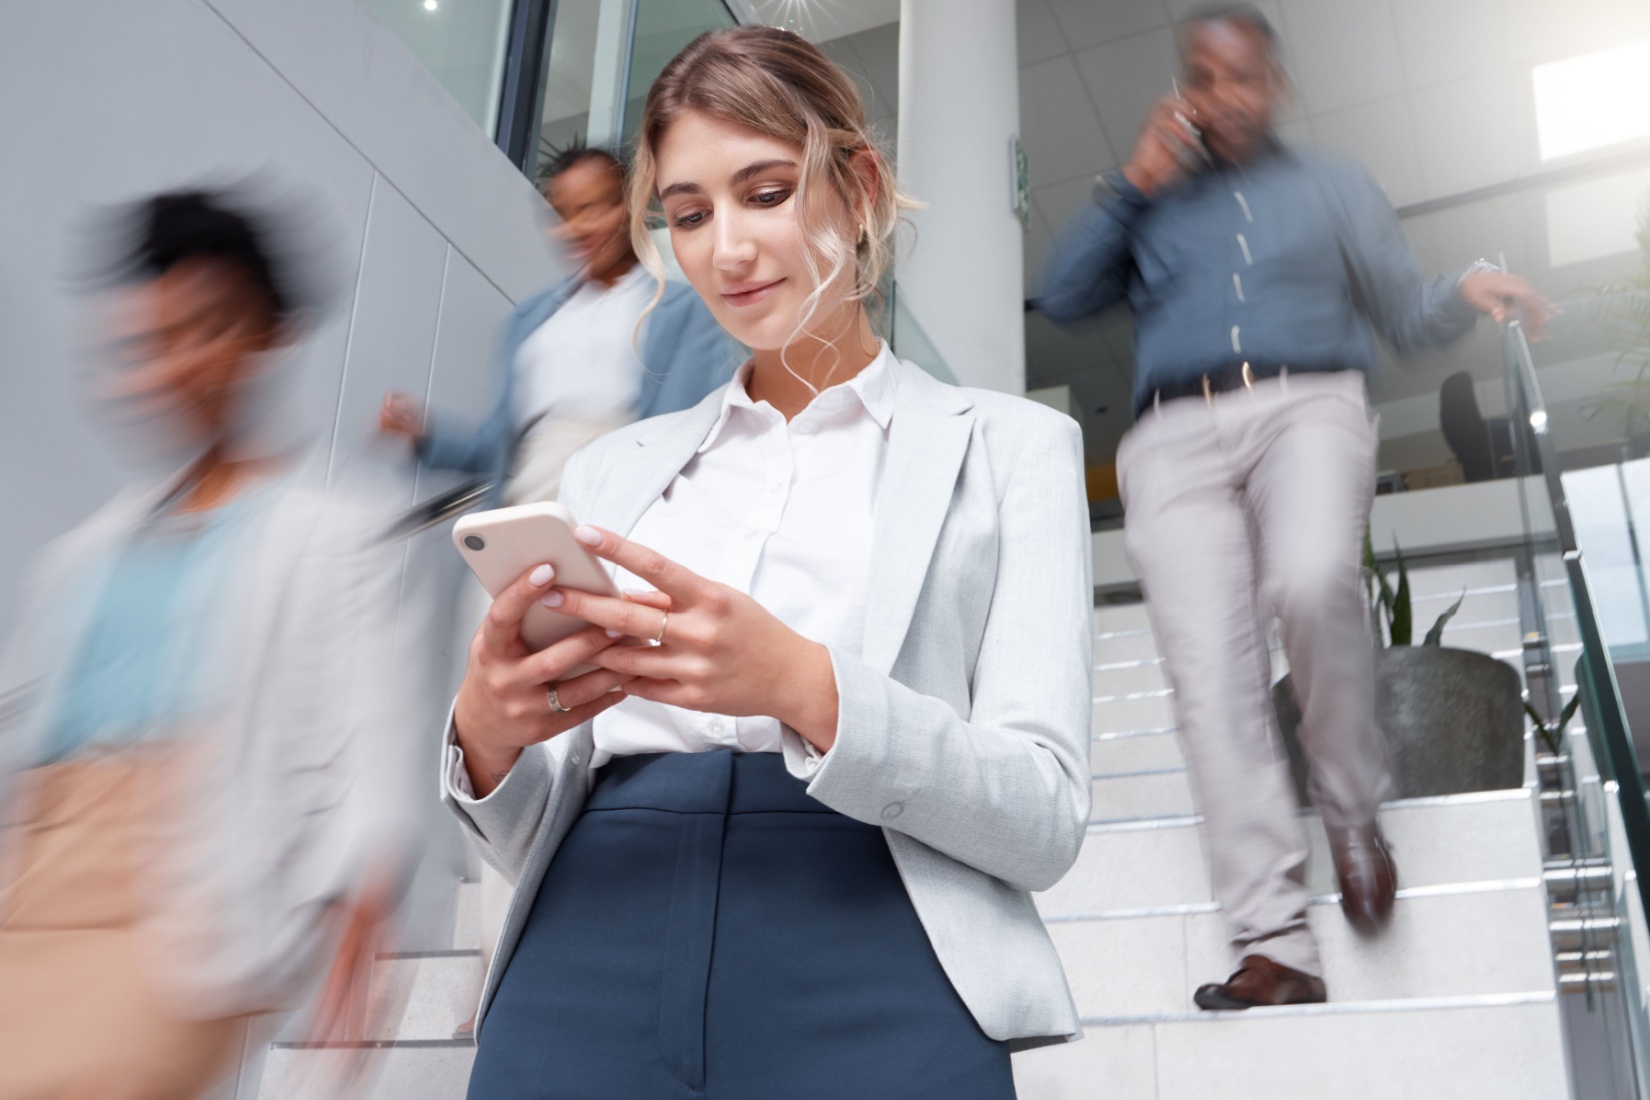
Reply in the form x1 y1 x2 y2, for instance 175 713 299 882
442 363 1092 1049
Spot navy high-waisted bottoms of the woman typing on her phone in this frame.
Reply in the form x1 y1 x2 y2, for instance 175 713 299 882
469 752 1015 1100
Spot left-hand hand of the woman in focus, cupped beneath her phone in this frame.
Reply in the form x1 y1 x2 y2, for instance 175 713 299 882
452 566 630 798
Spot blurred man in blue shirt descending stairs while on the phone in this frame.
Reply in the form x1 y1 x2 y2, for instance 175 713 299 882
1038 5 1544 1009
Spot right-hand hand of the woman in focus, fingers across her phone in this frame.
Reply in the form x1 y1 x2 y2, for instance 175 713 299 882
545 526 837 752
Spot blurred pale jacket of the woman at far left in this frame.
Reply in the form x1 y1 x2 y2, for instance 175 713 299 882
0 450 421 1016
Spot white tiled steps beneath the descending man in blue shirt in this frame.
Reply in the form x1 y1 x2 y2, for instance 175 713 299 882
1015 597 1569 1100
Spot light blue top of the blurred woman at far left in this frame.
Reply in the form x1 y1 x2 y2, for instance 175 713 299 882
38 491 262 765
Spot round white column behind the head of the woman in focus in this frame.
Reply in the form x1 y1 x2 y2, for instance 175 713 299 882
896 0 1026 394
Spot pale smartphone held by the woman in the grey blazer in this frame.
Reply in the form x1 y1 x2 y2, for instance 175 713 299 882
452 501 619 659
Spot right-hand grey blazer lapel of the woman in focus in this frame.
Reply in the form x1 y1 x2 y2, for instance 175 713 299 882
863 363 974 673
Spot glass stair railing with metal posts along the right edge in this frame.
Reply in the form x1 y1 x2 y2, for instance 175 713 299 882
1503 313 1650 1098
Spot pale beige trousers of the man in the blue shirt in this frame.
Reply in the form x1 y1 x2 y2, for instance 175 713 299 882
1117 371 1389 975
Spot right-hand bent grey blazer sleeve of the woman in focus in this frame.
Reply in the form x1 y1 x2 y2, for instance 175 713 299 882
809 419 1094 891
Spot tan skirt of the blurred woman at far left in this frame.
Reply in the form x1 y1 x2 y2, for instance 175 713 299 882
0 750 246 1100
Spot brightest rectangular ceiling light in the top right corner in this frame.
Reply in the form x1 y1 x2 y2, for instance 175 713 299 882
1531 41 1650 160
